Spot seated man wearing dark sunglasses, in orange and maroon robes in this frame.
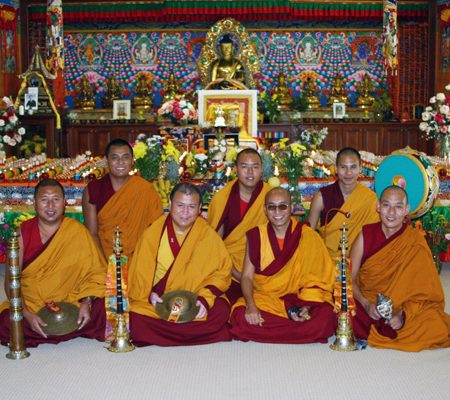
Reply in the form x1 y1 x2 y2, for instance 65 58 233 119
231 187 336 343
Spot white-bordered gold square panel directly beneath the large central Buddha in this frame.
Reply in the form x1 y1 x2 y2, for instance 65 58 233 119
198 90 258 138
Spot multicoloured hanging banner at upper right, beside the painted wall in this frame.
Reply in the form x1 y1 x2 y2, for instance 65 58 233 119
383 0 398 75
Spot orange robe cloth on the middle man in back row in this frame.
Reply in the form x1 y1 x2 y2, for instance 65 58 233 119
208 180 271 272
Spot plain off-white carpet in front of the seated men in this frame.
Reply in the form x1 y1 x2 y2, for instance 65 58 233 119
0 265 450 400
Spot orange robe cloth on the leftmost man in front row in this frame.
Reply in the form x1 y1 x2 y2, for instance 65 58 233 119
0 217 106 313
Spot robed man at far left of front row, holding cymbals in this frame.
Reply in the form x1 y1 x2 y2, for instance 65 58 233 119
0 179 106 347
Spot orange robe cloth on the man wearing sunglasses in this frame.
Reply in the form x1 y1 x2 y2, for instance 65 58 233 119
233 218 334 318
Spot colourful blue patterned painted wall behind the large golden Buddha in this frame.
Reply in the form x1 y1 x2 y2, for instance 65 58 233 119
64 31 386 108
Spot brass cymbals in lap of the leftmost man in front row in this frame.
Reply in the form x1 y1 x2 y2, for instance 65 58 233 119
37 302 80 336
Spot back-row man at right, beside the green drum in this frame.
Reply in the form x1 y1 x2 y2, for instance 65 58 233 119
308 147 379 258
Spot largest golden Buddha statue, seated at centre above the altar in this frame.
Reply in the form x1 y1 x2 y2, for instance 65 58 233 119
210 35 245 84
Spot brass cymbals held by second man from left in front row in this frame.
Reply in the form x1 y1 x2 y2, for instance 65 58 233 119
155 290 199 324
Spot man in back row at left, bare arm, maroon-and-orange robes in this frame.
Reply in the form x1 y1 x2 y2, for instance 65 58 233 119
82 139 163 262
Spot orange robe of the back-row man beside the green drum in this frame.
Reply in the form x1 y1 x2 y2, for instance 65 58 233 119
319 184 380 258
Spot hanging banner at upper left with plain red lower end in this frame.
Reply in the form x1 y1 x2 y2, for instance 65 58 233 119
47 0 65 109
